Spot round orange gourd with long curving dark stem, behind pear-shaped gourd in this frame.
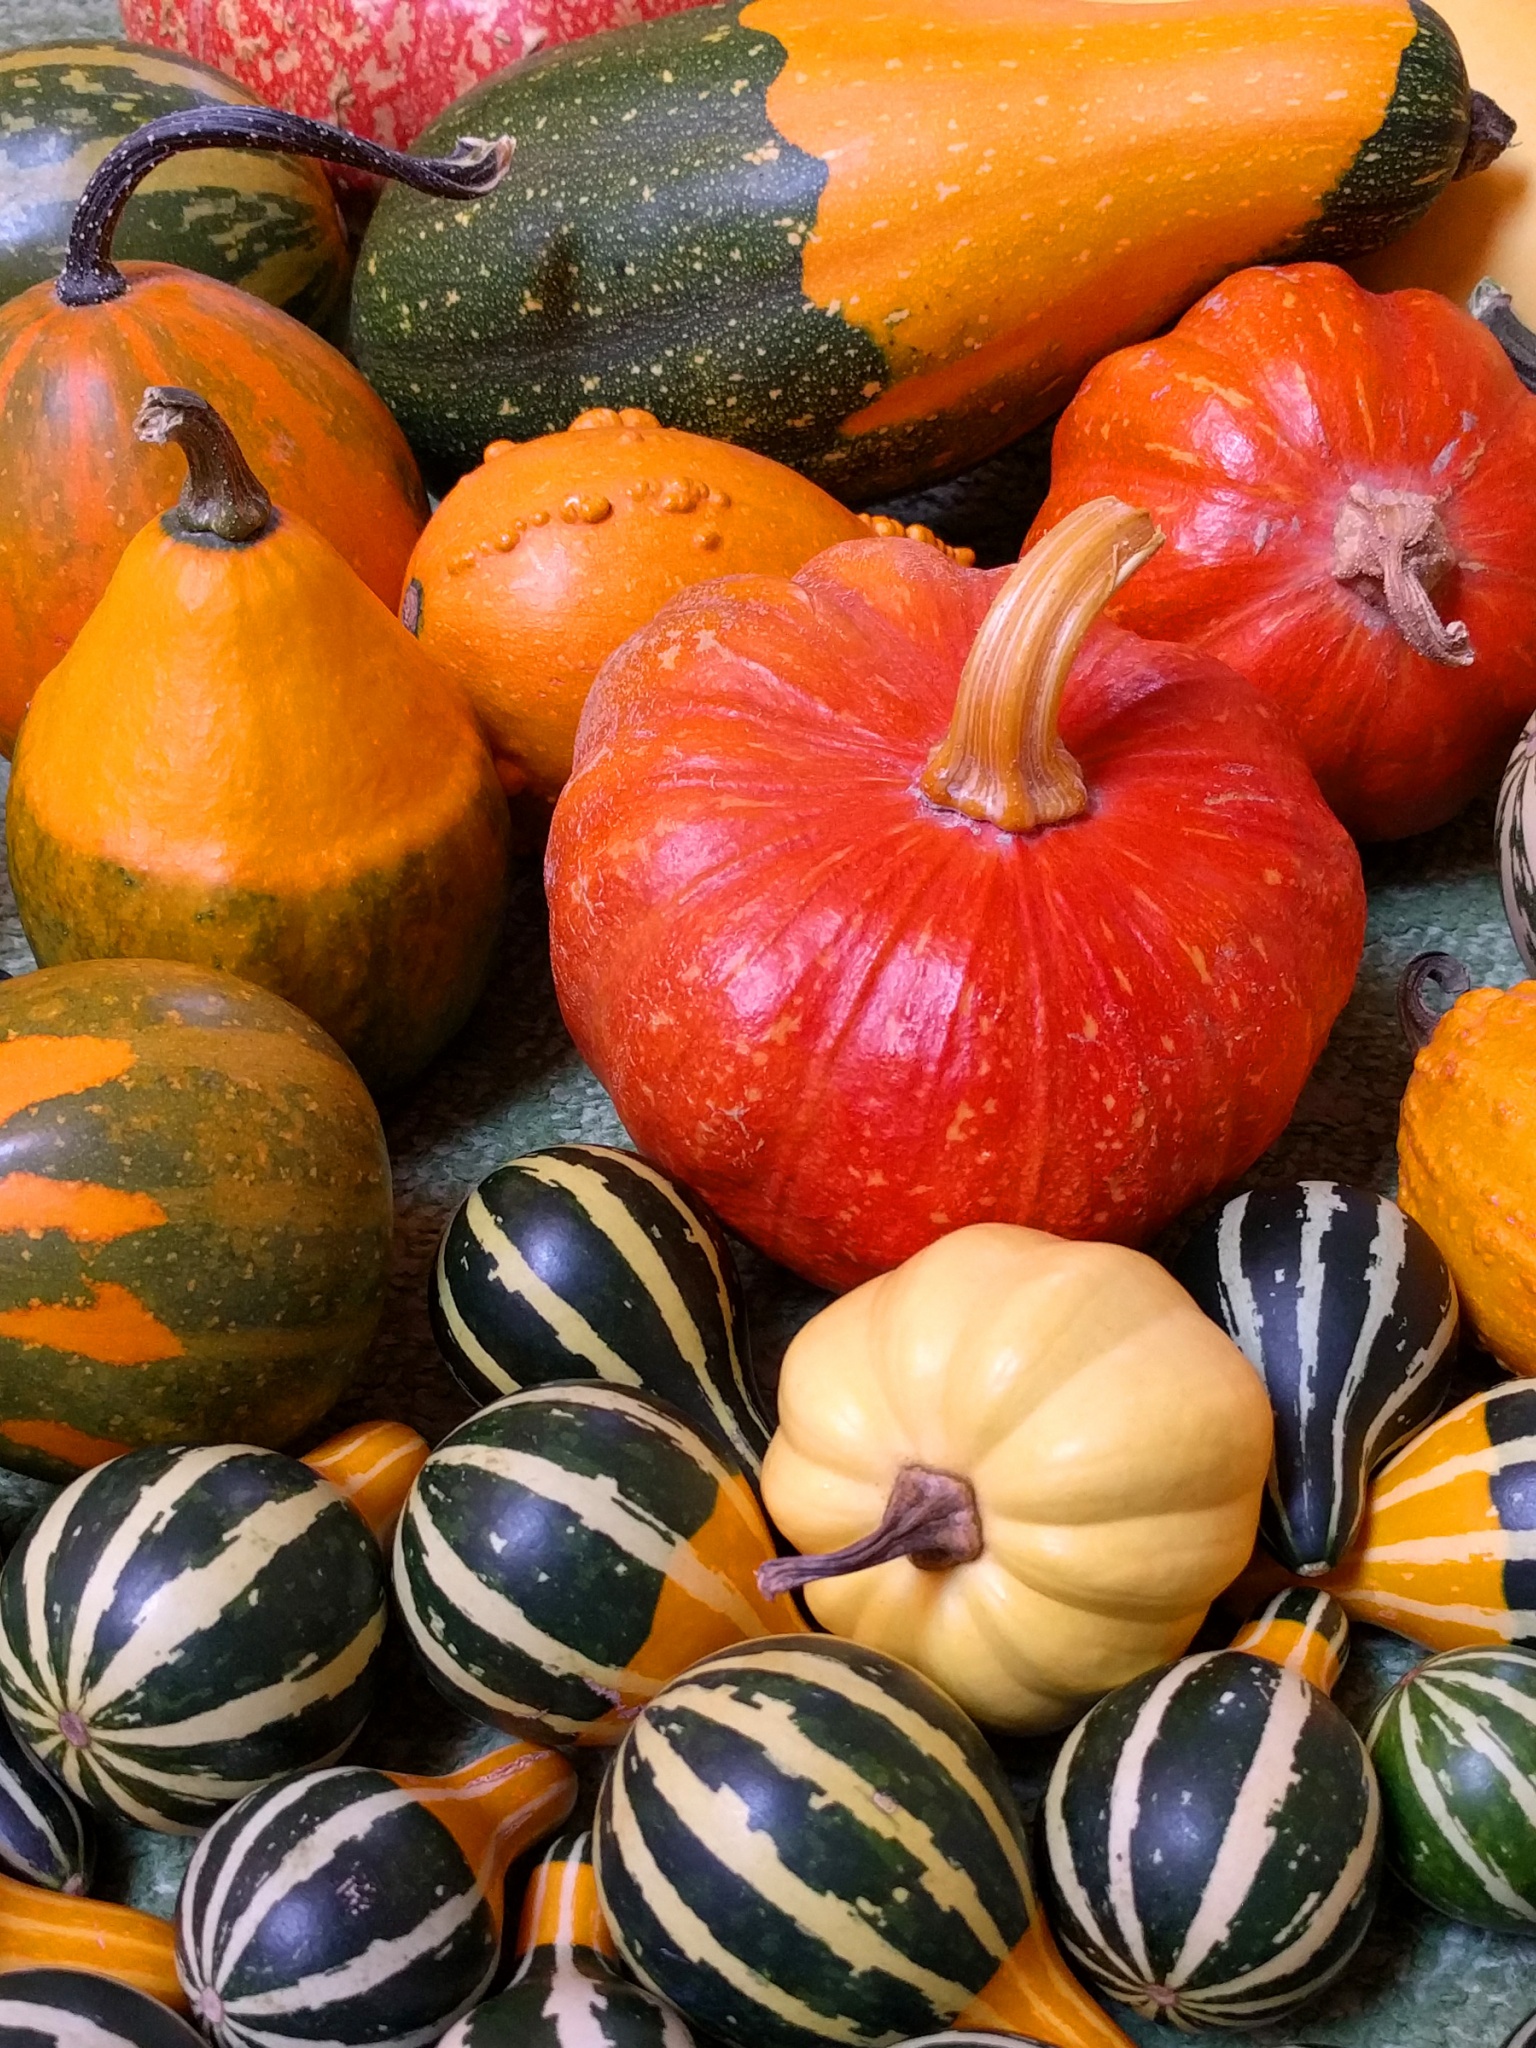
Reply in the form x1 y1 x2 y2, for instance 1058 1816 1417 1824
0 106 506 754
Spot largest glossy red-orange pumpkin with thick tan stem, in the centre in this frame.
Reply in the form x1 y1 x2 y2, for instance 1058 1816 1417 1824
547 502 1364 1286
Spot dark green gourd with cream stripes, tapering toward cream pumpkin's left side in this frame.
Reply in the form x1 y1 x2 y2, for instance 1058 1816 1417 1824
428 1145 768 1473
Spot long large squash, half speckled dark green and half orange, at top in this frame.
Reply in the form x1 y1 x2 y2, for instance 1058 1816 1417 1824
352 0 1501 504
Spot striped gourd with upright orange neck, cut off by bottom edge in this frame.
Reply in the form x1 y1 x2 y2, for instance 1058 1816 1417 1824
442 1833 694 2048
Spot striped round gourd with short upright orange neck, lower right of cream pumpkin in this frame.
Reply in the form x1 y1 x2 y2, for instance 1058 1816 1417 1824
1042 1593 1382 2030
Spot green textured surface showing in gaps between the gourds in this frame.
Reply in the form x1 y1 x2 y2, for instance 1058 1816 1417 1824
0 0 1536 2015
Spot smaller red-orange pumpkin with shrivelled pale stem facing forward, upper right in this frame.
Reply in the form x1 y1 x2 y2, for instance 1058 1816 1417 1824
1034 264 1536 840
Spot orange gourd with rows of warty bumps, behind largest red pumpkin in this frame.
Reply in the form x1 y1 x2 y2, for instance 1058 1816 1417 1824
401 406 974 805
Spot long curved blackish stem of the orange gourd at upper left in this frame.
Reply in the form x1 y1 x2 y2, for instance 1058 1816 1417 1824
53 106 512 305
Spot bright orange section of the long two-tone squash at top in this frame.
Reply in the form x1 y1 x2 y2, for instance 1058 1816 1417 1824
741 0 1415 434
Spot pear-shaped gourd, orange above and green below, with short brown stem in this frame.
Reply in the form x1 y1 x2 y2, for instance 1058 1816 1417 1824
8 387 508 1087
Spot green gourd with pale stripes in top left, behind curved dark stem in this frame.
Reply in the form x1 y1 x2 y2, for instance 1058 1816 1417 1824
0 39 350 329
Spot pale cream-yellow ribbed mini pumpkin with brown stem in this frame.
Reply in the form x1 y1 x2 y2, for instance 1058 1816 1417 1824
760 1223 1272 1735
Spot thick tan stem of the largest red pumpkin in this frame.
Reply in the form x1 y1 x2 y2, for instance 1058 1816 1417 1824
922 498 1163 831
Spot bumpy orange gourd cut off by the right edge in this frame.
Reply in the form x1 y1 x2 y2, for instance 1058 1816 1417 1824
1397 981 1536 1374
